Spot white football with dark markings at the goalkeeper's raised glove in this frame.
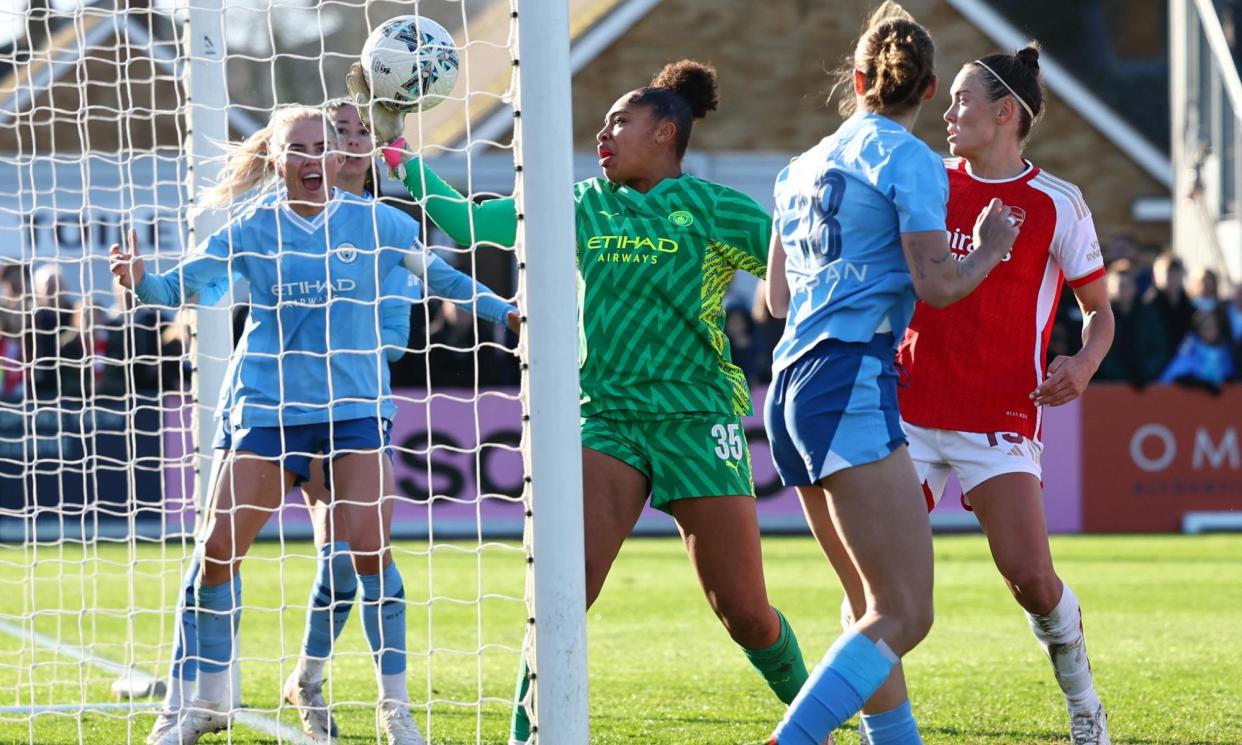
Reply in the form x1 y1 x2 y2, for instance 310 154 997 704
361 15 461 112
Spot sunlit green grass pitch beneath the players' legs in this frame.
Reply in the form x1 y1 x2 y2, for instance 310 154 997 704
0 535 1242 745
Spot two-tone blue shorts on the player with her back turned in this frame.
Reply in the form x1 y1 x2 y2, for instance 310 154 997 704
764 334 905 487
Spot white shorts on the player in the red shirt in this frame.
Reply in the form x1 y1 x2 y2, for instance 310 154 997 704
902 421 1043 512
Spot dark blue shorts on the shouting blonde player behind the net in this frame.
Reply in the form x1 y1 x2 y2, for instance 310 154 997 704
212 418 392 485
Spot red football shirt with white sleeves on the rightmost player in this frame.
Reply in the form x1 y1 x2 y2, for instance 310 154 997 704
898 159 1104 441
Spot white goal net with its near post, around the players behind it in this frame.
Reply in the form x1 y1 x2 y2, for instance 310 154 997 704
0 0 586 744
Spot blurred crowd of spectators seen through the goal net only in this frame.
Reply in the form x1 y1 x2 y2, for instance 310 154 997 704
0 244 519 407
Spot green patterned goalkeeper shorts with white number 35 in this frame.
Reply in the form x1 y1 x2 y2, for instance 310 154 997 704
582 413 755 513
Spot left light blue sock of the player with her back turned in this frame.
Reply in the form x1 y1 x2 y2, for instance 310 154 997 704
770 631 897 745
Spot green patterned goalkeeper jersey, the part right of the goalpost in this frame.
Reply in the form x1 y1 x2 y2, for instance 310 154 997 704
574 175 771 417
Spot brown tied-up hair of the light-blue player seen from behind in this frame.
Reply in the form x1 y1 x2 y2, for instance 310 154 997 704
828 0 935 117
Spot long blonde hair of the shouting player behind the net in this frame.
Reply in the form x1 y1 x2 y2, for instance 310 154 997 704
197 106 338 209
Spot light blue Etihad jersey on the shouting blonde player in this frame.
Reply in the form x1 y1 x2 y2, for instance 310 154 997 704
138 191 422 427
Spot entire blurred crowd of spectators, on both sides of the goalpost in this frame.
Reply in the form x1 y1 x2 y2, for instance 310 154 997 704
0 229 1242 406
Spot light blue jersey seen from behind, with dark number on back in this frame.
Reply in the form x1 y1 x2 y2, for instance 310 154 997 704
773 112 949 371
